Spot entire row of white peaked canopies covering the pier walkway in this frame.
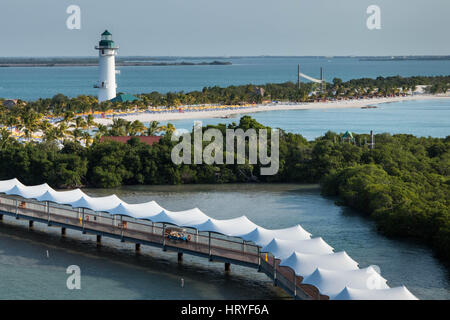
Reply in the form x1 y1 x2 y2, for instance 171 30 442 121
0 179 417 300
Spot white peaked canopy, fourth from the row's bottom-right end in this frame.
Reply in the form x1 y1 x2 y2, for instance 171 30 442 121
261 237 333 260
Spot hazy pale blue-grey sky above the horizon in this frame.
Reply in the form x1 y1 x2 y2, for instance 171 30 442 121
0 0 450 57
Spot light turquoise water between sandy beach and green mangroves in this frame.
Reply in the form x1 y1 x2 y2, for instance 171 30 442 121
161 98 450 140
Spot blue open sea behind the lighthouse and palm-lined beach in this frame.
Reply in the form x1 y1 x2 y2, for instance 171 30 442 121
0 57 450 100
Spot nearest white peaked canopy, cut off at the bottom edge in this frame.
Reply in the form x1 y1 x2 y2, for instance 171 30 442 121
334 286 418 300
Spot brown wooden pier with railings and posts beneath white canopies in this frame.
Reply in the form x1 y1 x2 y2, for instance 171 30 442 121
0 195 328 300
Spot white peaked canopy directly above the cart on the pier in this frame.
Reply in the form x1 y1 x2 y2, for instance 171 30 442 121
150 208 209 227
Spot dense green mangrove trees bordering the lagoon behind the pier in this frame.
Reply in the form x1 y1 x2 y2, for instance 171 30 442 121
0 116 450 260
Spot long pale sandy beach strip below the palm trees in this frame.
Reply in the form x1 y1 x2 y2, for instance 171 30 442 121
95 94 450 125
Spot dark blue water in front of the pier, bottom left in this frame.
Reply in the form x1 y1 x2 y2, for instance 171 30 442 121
0 217 289 299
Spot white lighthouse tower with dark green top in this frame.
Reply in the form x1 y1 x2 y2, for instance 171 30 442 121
94 30 119 102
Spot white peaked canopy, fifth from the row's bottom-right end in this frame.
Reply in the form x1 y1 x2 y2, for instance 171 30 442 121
238 224 311 247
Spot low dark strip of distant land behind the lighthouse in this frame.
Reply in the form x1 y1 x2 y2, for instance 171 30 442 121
0 57 232 67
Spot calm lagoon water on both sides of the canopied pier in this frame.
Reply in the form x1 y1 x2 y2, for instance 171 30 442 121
0 184 450 299
